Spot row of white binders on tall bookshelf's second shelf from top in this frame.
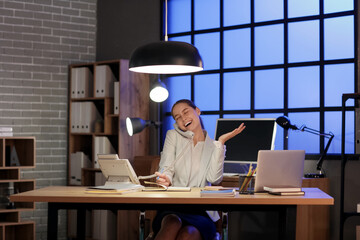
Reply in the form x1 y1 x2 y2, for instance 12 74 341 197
70 102 103 133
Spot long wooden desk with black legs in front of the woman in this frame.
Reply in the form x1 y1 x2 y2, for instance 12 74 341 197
10 186 334 240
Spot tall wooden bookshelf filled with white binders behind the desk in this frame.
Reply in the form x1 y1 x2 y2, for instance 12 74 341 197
67 59 150 239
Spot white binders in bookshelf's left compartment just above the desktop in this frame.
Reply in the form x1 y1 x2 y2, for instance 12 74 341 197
70 152 91 185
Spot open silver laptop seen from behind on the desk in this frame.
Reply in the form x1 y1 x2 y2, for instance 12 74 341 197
254 150 305 192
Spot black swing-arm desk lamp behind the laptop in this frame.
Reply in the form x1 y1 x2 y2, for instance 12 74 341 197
276 116 334 178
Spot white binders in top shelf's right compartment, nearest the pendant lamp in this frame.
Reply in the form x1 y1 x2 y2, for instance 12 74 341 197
95 65 116 97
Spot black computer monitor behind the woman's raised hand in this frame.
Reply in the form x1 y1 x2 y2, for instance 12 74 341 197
215 118 276 163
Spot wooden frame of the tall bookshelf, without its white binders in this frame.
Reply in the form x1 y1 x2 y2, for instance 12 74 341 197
68 59 150 239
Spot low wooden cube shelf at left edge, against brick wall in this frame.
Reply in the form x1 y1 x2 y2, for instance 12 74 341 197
0 137 36 240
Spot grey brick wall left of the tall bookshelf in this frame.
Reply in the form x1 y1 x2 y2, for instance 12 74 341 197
0 0 96 239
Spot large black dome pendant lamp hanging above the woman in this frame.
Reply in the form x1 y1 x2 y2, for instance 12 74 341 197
129 0 203 74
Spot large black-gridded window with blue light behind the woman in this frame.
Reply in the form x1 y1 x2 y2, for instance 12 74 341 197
162 0 358 154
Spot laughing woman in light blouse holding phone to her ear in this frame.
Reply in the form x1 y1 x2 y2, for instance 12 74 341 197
149 99 245 240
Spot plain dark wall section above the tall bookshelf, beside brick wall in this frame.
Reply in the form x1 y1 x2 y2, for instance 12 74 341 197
96 0 161 61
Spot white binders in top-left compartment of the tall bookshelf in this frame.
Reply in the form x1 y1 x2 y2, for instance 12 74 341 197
71 67 93 98
